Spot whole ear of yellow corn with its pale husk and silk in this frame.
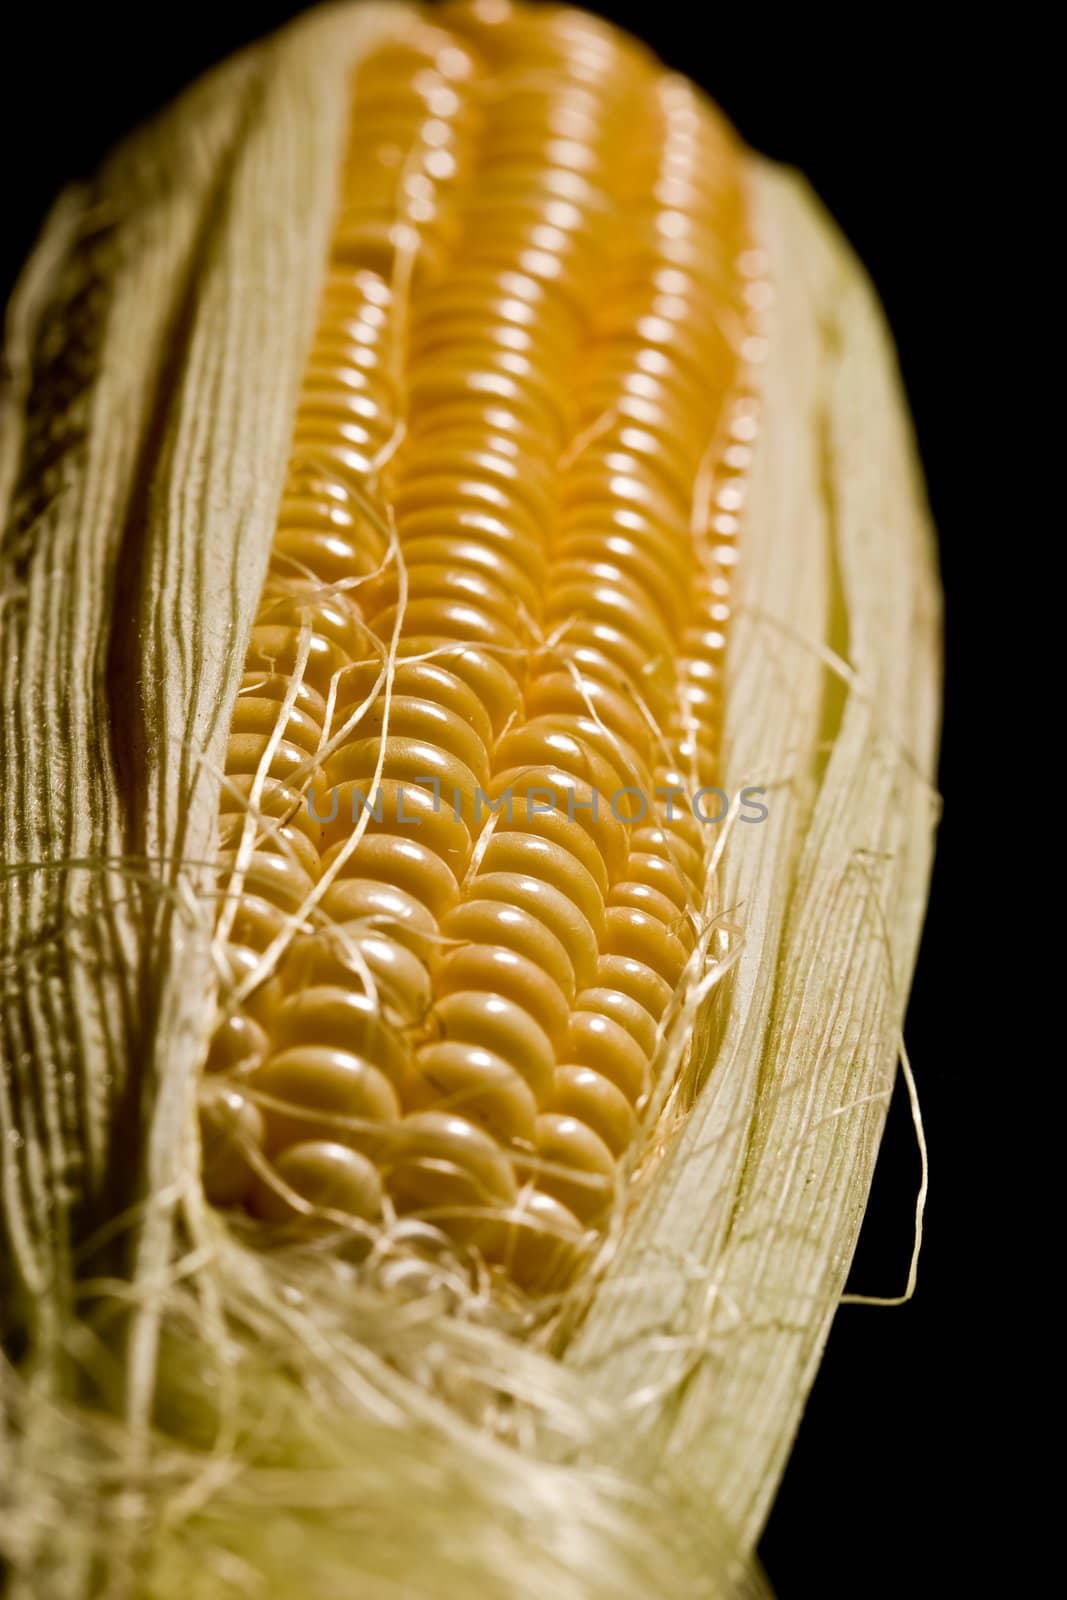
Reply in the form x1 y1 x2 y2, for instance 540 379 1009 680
0 3 937 1600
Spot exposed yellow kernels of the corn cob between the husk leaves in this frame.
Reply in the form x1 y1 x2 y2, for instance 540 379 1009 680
205 5 766 1277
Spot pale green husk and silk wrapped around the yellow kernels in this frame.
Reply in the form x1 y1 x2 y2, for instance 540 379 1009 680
0 5 939 1600
